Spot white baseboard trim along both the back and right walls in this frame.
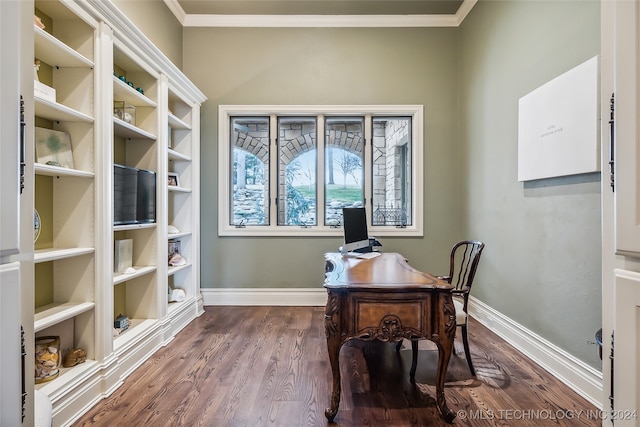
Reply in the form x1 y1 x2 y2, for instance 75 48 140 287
201 288 603 409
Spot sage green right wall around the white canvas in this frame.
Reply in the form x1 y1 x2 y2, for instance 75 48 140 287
459 1 602 369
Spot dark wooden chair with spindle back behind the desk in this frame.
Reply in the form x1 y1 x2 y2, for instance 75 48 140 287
396 240 484 378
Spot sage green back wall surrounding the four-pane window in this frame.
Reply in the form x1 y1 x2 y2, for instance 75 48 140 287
183 28 465 289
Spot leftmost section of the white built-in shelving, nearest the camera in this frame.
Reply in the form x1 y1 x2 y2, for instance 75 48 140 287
32 1 104 424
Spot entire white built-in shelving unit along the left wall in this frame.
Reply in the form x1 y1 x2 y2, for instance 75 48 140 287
21 0 205 426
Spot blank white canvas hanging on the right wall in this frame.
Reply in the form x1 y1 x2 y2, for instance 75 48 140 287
518 56 600 181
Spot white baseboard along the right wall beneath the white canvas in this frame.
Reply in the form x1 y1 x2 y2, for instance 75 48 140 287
469 297 603 409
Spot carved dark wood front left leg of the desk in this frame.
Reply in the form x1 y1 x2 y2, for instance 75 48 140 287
324 291 342 422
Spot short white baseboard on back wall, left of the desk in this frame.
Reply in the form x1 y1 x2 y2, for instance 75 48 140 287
200 288 327 307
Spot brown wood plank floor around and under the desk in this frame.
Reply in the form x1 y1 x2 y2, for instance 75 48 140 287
74 306 602 427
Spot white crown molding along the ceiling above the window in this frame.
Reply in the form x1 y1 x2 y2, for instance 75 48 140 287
164 0 478 28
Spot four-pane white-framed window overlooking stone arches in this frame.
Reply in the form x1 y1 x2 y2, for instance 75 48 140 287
218 106 423 236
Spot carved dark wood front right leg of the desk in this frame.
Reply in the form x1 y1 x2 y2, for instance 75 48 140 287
434 293 456 423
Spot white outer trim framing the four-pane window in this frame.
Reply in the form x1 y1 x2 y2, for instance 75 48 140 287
218 105 424 237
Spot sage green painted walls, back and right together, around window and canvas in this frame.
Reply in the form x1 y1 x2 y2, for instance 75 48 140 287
174 0 601 368
